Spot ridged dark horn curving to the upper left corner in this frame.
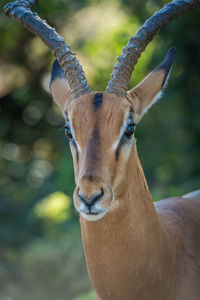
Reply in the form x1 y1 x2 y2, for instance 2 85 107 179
4 0 91 99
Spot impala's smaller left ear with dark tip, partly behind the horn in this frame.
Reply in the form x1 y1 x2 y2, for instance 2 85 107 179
50 60 72 115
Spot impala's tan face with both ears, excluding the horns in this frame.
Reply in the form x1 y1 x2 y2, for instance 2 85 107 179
50 50 175 221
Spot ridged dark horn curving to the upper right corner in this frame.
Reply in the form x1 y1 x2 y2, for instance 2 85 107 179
106 0 200 97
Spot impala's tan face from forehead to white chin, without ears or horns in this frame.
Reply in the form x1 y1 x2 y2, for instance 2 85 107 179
65 93 135 220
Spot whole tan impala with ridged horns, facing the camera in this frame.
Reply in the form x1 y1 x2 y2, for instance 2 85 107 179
5 0 200 300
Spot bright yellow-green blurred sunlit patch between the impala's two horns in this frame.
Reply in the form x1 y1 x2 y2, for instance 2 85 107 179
58 1 139 85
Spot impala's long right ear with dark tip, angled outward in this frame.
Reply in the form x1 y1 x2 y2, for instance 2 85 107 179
127 48 176 122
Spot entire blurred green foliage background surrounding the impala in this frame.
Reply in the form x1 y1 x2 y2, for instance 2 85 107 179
0 0 200 300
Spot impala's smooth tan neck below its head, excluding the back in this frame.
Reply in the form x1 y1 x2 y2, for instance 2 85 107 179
80 146 168 299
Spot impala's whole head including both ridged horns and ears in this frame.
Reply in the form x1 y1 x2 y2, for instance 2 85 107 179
5 0 200 220
